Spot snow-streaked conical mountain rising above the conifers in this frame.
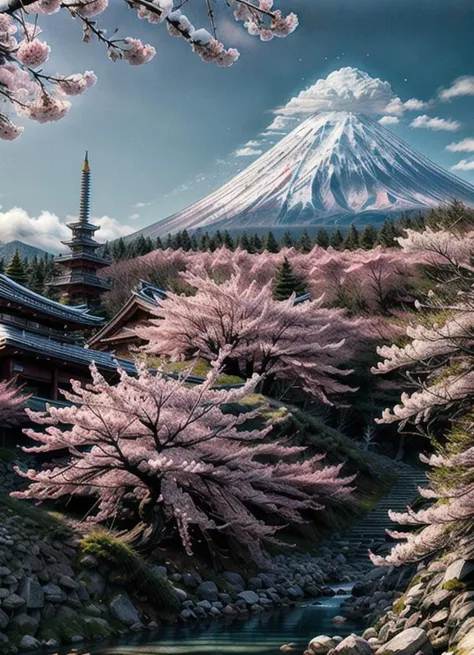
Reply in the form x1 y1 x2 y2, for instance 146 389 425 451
129 112 474 238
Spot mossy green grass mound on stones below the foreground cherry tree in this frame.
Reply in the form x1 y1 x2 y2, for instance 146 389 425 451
80 532 180 618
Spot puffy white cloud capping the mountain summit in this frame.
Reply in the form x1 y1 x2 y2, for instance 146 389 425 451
275 66 425 116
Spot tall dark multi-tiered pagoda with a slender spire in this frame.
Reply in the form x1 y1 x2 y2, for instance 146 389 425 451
49 151 112 307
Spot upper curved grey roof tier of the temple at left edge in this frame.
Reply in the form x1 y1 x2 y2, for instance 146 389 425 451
0 273 104 326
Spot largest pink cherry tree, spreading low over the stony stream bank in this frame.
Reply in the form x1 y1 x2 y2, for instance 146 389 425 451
13 356 352 561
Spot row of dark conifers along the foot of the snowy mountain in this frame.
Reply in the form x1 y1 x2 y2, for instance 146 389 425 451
112 215 424 261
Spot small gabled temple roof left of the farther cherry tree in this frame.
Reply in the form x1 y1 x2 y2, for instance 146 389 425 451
88 280 166 354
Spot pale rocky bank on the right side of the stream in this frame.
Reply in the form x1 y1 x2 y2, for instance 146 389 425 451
306 537 474 655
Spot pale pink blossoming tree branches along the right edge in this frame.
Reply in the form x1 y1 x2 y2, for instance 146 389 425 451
372 225 474 566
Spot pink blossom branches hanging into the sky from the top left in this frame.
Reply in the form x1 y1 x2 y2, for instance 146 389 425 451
0 0 298 141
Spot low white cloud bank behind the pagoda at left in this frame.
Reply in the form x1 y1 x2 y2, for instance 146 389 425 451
0 207 134 253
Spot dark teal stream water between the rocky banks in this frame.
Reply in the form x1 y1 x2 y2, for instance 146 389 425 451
62 585 363 655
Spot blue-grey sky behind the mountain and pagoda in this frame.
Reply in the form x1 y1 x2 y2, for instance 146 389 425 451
0 0 474 248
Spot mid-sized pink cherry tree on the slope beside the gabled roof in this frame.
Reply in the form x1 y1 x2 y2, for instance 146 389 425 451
137 268 372 402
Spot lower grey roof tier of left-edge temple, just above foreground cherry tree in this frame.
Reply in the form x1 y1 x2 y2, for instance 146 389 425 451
0 324 136 374
